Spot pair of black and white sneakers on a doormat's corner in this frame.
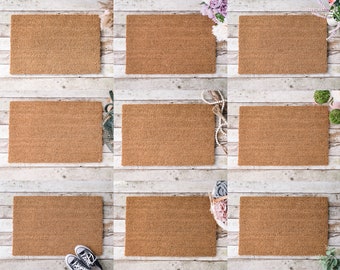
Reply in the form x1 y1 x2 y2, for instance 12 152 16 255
65 245 103 270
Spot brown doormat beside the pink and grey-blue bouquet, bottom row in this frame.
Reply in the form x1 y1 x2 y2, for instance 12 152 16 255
125 197 216 257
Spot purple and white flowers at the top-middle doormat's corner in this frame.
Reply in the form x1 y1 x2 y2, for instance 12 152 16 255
201 0 228 41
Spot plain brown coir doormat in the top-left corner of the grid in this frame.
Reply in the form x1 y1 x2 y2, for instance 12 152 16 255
10 15 100 74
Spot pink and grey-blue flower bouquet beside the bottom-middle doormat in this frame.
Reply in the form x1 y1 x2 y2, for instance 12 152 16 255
209 180 228 230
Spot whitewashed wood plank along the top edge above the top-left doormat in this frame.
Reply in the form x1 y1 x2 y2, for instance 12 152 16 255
0 0 112 12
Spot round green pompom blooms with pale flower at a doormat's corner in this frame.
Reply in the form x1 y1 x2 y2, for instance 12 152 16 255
314 90 340 124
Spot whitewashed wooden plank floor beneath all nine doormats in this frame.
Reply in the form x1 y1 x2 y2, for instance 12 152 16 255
0 0 340 270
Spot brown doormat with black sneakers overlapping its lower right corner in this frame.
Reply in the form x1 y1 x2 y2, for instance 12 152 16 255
13 196 103 256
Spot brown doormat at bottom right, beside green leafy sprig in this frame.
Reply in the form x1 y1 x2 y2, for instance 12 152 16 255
239 197 328 256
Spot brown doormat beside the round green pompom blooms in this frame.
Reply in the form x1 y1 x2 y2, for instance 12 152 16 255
238 106 329 166
